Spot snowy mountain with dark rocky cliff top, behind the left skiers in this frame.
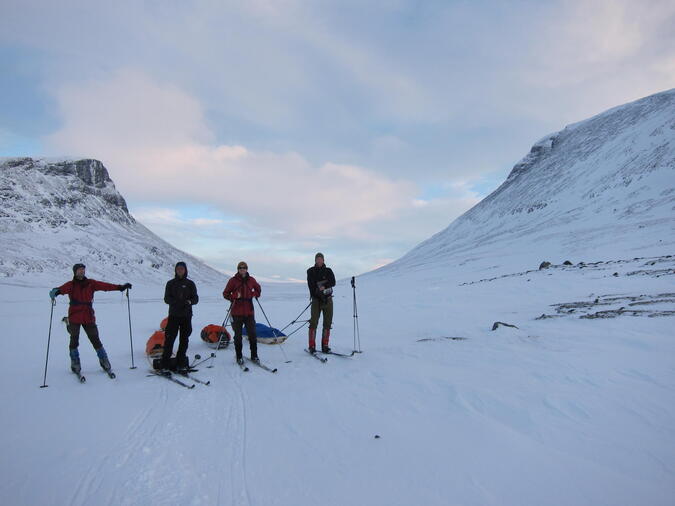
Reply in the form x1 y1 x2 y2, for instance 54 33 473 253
0 158 225 282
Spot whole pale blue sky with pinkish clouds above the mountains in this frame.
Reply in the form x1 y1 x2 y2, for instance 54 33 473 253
0 0 675 280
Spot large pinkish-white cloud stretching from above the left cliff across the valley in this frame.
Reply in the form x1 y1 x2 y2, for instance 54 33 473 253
46 70 416 238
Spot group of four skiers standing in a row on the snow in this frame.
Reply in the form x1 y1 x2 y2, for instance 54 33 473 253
49 253 335 375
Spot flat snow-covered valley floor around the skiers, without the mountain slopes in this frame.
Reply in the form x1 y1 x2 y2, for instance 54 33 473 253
0 251 675 505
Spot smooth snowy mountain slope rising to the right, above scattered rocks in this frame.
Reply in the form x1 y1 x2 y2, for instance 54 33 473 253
379 89 675 273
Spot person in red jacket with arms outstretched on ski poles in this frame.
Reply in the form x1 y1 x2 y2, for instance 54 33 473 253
49 264 131 374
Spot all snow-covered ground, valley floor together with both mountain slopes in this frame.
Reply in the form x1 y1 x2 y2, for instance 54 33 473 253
0 90 675 506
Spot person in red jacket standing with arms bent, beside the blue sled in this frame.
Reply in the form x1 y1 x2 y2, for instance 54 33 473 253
223 262 261 364
